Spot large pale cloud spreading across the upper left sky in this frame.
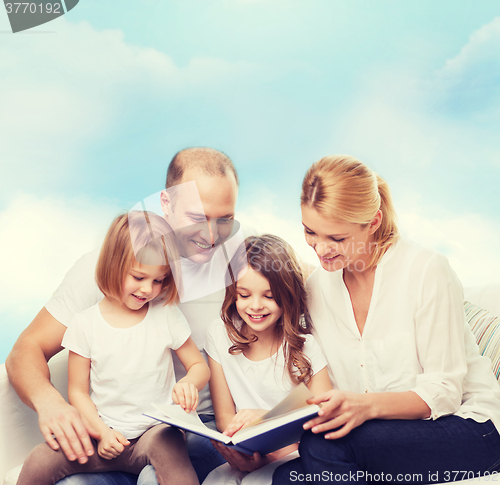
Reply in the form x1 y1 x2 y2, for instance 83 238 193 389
0 17 265 197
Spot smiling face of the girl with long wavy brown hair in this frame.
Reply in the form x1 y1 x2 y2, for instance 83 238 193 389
236 266 283 336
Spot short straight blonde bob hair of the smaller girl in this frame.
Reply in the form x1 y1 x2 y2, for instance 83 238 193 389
95 211 179 304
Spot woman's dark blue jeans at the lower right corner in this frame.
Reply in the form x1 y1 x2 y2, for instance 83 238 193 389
273 416 500 485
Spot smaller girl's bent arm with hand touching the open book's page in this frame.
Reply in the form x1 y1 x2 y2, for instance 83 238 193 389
172 337 210 413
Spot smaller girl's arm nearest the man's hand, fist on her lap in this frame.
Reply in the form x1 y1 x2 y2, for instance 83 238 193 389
68 351 130 460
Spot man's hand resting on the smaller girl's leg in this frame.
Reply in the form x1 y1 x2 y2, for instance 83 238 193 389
37 398 100 463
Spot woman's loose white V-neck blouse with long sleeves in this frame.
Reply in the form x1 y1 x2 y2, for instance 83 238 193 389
306 239 500 430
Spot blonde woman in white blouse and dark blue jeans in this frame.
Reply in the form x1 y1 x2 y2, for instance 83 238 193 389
273 156 500 484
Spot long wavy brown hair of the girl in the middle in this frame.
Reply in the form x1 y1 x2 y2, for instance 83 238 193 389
221 234 312 384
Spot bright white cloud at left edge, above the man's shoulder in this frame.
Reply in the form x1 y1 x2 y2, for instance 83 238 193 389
0 194 120 318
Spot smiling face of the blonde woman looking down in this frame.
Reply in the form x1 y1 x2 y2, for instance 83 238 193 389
302 205 381 271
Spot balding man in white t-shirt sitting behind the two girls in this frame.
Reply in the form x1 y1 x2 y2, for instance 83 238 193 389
5 147 238 485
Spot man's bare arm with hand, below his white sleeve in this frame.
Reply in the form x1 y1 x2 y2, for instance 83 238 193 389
5 307 98 463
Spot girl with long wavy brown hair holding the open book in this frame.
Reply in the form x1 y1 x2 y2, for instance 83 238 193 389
205 235 331 483
